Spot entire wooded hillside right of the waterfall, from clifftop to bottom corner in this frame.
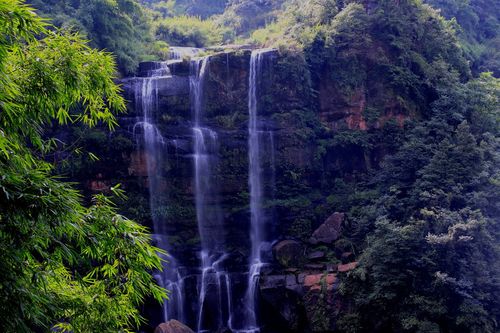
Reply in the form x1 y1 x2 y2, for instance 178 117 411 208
247 1 500 332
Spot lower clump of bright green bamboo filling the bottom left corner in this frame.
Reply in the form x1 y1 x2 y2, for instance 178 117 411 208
0 156 166 332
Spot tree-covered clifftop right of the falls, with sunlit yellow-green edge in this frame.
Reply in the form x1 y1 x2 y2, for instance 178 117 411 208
254 1 469 113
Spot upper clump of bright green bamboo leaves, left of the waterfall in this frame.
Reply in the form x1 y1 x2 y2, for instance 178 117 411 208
4 32 124 139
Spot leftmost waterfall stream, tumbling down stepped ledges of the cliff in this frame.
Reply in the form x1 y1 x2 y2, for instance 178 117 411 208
133 63 185 321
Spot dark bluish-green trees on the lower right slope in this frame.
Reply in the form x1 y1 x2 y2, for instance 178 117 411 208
339 75 500 332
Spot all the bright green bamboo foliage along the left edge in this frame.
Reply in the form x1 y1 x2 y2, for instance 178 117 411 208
0 0 166 332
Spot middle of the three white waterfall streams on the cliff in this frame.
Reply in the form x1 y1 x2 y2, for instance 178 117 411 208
190 57 232 332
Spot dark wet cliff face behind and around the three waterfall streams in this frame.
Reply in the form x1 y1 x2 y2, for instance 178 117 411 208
73 50 410 332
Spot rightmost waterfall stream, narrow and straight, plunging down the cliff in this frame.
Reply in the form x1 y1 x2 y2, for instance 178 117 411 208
242 49 274 332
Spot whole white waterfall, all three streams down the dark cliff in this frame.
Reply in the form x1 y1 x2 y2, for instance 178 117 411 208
129 48 275 333
